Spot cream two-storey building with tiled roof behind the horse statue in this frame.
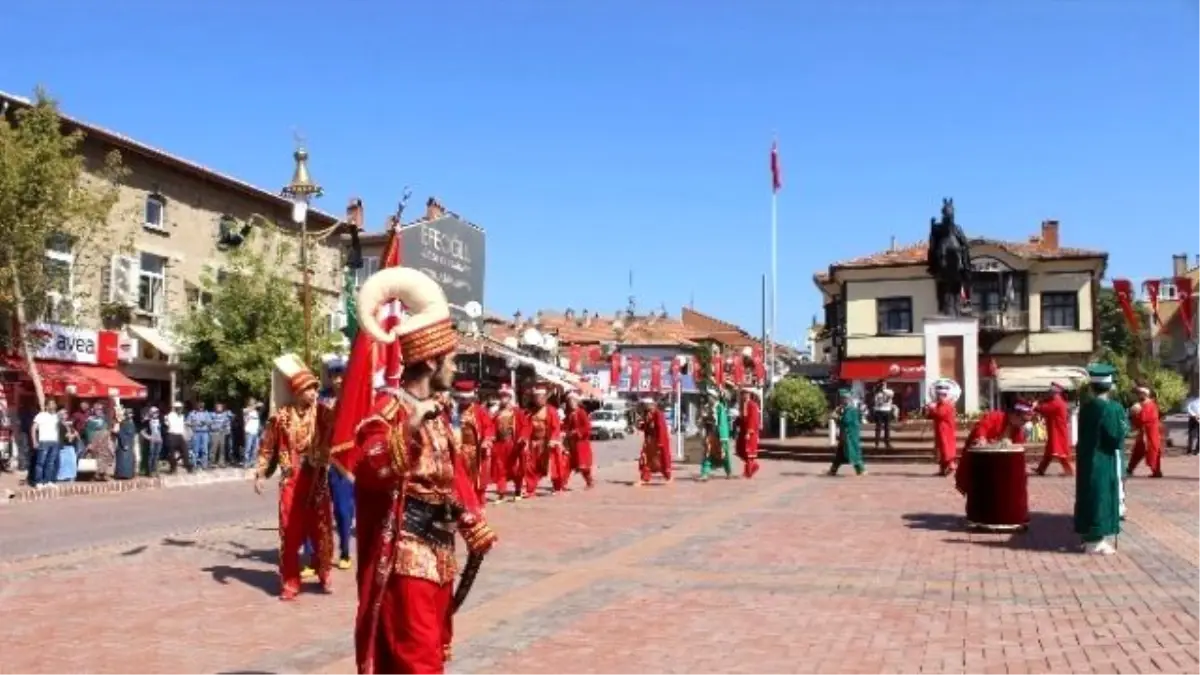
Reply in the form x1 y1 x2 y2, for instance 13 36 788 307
815 221 1108 411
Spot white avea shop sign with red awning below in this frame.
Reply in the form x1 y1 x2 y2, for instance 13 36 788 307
2 324 146 407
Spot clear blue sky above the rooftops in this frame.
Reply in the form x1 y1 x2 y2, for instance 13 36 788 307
9 0 1200 340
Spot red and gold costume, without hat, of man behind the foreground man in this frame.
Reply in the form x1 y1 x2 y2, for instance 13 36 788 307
257 404 334 599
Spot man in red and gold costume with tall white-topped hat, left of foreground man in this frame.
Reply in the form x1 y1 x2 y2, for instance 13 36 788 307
254 354 334 601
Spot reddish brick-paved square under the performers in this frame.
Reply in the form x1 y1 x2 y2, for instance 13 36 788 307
7 446 1200 675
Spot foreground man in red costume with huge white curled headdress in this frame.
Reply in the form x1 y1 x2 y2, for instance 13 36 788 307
335 267 496 675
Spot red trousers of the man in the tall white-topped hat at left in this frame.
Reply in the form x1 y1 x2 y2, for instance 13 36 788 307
280 466 334 595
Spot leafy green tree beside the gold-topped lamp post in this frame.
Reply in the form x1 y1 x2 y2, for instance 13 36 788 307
176 223 336 401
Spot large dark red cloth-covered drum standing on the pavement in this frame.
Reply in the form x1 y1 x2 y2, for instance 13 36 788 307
967 446 1030 530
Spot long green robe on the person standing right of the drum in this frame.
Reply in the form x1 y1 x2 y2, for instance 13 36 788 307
1075 396 1126 542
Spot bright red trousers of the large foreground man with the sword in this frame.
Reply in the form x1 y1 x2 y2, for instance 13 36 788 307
376 574 454 675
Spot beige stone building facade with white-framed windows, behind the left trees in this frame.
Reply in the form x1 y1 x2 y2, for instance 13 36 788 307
0 94 342 405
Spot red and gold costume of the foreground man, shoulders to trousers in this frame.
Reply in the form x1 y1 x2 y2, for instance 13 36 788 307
347 395 496 675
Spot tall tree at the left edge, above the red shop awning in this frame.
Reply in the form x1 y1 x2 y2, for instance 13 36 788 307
0 90 125 405
